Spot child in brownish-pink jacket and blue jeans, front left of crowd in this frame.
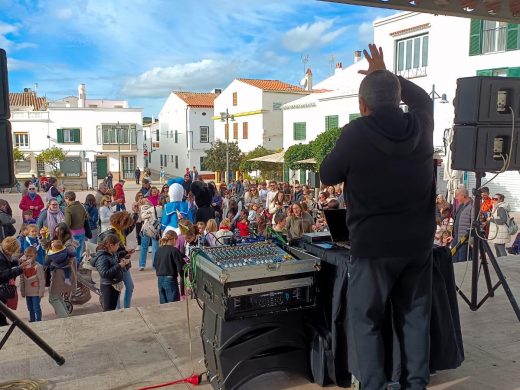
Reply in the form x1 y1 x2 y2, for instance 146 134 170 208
20 246 45 322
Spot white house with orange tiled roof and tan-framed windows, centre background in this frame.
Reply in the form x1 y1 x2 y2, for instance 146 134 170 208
213 79 312 153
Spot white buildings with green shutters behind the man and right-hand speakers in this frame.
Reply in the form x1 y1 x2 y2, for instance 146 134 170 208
284 12 520 210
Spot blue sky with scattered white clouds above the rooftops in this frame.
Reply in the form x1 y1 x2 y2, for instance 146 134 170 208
0 0 395 116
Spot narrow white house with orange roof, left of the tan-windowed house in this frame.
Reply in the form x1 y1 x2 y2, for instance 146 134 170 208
155 91 218 176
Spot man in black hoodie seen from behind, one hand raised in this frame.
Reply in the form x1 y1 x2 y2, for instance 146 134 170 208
320 45 435 390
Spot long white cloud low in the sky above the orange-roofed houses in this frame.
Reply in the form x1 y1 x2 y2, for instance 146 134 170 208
122 59 242 97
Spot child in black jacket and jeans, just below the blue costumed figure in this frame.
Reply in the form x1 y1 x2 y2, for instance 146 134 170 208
153 230 184 304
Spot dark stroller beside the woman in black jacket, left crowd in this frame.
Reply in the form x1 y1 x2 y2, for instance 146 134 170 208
64 242 103 314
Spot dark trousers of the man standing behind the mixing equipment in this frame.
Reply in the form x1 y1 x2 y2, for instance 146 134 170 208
347 251 433 390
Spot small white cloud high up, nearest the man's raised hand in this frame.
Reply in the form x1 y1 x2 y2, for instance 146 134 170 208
282 20 348 52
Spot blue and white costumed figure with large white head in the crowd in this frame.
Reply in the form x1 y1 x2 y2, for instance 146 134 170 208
161 177 195 234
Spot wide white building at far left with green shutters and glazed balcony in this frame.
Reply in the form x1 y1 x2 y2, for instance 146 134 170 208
9 84 142 187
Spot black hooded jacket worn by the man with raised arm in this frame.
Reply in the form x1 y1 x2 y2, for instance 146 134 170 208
320 77 435 257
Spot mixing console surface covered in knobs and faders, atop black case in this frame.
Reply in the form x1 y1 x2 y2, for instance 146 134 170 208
205 241 295 269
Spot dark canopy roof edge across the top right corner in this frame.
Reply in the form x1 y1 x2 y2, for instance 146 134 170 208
322 0 520 23
